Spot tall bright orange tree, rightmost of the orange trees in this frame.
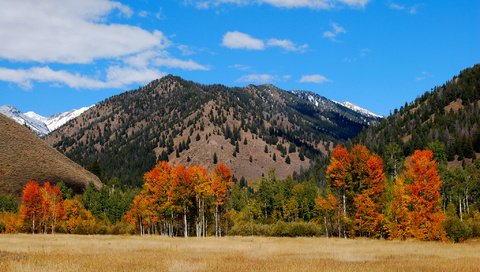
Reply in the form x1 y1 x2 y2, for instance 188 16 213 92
405 150 445 240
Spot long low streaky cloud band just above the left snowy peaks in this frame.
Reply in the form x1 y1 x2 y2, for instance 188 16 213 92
0 66 164 89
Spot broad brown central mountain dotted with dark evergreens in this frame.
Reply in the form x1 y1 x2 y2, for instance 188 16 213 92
46 75 380 185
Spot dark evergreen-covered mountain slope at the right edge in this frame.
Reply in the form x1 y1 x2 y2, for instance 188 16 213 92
359 64 480 163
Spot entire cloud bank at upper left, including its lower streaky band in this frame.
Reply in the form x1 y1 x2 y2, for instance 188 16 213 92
0 0 209 89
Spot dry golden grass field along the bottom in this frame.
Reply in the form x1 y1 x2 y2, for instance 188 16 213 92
0 234 480 272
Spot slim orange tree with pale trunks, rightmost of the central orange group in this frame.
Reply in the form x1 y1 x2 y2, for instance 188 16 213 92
211 163 233 236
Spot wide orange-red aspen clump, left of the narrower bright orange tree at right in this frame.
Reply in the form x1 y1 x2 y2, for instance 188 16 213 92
327 145 386 237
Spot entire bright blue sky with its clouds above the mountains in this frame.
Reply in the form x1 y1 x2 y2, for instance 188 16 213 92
0 0 480 116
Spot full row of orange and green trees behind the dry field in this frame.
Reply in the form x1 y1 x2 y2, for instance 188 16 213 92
0 143 480 241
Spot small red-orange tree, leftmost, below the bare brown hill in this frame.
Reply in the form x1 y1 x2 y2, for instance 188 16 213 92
20 180 43 234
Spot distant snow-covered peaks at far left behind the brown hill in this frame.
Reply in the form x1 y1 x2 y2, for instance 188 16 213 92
0 105 92 136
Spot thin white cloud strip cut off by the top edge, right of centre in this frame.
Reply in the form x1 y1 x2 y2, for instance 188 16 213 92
187 0 369 9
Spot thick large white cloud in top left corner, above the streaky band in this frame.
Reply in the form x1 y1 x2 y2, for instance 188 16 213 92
0 0 168 63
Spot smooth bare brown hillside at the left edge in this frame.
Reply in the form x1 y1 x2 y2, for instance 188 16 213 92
0 114 101 196
